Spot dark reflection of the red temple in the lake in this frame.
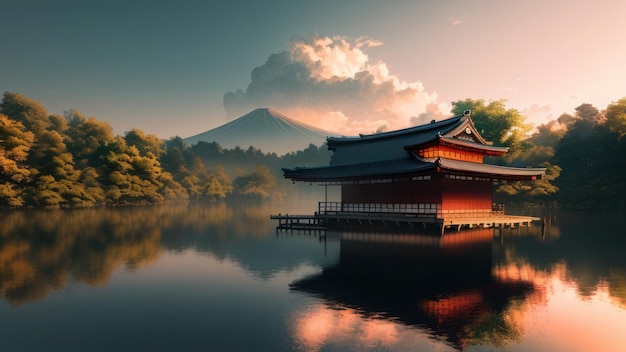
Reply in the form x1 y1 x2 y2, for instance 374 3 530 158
291 229 536 349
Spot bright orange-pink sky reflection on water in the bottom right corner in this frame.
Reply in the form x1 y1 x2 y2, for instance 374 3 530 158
494 264 626 351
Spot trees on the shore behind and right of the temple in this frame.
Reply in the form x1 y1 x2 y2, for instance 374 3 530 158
453 98 626 209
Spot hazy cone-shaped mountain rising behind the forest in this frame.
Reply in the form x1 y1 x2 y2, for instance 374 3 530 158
183 108 337 155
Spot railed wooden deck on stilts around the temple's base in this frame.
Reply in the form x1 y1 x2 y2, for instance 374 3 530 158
270 213 540 235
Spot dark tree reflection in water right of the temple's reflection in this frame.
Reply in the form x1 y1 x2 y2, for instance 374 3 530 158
494 210 626 307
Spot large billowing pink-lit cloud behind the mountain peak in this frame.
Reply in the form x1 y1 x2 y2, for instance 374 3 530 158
223 34 439 134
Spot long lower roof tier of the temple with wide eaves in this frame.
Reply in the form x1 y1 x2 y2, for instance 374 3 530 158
283 158 546 182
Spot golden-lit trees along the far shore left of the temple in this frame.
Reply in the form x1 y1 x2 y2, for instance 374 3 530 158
0 92 329 208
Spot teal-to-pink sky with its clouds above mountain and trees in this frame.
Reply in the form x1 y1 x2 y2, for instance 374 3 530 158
0 0 626 138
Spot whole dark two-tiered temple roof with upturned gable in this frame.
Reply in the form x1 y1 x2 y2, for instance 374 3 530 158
283 111 545 182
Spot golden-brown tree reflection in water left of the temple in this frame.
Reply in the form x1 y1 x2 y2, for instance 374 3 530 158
0 203 271 305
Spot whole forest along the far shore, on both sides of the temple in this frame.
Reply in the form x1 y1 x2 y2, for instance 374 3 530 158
0 92 626 209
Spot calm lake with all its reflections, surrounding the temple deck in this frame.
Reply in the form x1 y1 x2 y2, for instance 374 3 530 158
0 199 626 351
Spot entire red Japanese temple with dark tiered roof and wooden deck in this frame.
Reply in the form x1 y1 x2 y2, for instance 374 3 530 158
272 110 545 233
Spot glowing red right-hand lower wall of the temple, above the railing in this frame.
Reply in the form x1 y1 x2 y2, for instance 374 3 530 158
441 179 493 214
